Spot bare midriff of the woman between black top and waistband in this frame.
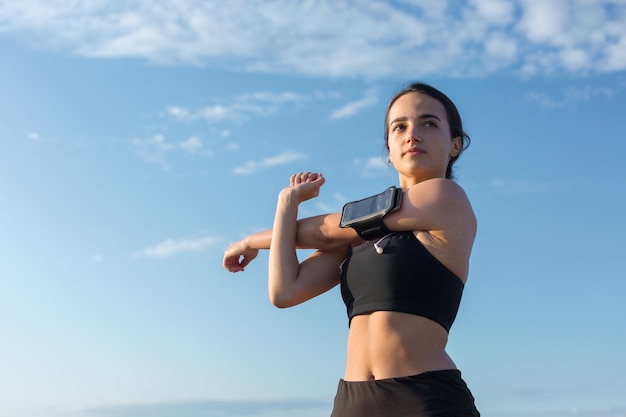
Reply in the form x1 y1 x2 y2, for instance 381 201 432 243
344 311 456 381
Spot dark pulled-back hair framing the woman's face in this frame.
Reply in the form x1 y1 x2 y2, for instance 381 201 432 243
385 83 471 179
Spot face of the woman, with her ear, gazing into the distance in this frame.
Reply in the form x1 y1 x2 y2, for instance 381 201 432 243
387 92 461 188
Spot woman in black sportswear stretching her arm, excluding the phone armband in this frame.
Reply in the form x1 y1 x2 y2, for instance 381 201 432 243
224 83 479 417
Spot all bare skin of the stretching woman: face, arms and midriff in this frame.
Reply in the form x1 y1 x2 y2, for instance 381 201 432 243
224 93 476 381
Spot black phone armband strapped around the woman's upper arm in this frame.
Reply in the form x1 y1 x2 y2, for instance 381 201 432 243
339 186 402 240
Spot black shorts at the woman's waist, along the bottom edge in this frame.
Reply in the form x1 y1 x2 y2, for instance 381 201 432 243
331 369 480 417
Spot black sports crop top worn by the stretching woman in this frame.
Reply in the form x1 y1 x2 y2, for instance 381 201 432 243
341 231 464 332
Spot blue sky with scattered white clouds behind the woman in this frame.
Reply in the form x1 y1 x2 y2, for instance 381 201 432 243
0 0 626 417
